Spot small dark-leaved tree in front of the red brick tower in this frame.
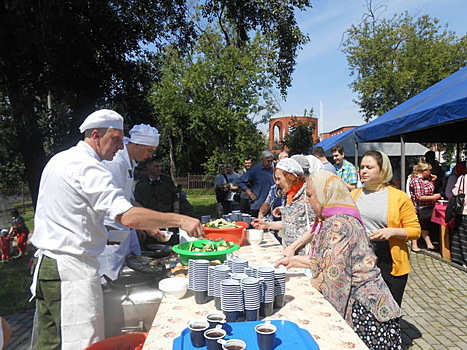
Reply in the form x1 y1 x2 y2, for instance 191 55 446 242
282 116 316 156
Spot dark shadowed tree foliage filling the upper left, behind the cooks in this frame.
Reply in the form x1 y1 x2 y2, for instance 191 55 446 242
0 0 310 201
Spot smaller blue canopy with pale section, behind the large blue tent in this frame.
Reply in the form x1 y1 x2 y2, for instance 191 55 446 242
314 127 428 157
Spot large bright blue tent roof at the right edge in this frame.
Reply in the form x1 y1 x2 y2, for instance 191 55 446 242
354 67 467 142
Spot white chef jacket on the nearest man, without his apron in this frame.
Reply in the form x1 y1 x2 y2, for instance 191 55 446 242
31 141 132 257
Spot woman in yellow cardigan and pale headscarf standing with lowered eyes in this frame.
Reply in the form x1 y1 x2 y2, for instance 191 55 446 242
352 151 421 305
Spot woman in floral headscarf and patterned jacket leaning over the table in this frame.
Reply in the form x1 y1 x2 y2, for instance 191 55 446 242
276 171 402 349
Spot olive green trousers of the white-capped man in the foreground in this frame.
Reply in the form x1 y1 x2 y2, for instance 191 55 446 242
36 256 61 350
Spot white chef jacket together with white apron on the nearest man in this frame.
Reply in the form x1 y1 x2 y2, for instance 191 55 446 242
31 141 132 350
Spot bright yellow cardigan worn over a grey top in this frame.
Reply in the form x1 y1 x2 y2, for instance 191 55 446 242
352 186 421 276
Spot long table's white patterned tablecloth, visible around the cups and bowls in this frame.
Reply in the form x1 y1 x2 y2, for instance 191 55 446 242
143 232 368 350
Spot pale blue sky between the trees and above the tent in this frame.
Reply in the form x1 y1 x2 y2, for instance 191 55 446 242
266 0 467 133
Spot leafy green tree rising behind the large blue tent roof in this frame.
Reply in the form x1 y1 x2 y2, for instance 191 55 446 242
343 4 467 122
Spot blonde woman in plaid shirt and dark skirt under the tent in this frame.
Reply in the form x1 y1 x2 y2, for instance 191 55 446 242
409 160 441 253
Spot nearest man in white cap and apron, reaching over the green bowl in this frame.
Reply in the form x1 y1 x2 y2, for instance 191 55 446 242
31 109 203 350
